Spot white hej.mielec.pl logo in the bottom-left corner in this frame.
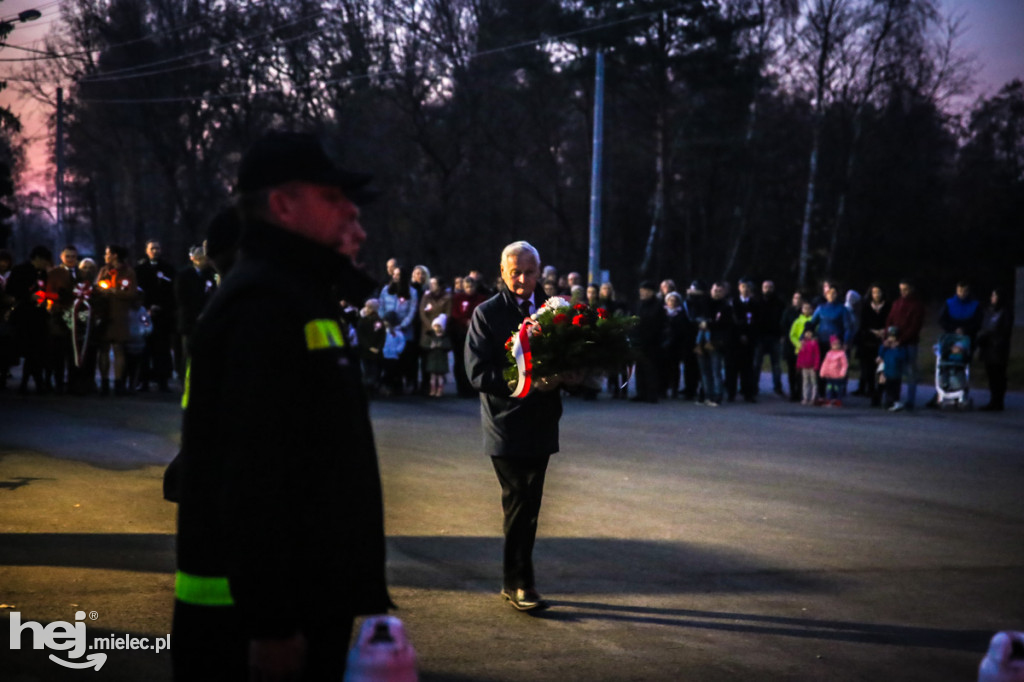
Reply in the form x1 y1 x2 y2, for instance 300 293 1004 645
10 611 171 670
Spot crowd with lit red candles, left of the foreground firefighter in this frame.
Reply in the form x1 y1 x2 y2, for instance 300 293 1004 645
0 240 218 395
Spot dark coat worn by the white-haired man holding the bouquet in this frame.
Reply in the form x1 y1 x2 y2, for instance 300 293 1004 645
465 290 562 457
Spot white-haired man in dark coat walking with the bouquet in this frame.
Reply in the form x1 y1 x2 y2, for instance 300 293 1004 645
465 242 574 611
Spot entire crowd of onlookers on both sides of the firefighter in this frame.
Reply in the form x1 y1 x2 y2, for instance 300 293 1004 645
0 240 1013 412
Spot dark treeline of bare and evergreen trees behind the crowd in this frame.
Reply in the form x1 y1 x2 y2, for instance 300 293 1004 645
8 0 1024 292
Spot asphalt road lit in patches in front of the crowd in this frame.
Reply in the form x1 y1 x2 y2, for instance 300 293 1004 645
0 378 1024 682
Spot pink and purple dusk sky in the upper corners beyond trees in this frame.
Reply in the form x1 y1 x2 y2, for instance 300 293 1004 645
0 0 1024 192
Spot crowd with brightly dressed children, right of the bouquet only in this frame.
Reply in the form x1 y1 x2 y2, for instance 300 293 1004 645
612 279 1013 412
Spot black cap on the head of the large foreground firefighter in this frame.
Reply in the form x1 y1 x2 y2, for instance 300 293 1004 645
236 130 374 204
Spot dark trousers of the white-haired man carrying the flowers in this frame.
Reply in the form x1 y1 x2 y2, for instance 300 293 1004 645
490 455 550 590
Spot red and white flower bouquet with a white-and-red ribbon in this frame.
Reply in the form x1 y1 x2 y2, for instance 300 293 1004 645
504 296 637 397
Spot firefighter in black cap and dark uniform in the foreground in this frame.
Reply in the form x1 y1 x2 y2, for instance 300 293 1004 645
165 132 391 682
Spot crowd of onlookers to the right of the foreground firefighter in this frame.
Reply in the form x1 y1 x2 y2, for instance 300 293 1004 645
350 266 1013 412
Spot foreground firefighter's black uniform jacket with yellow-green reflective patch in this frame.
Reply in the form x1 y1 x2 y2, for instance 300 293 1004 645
168 224 390 637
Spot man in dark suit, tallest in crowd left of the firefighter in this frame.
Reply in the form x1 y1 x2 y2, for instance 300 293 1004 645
135 240 175 392
